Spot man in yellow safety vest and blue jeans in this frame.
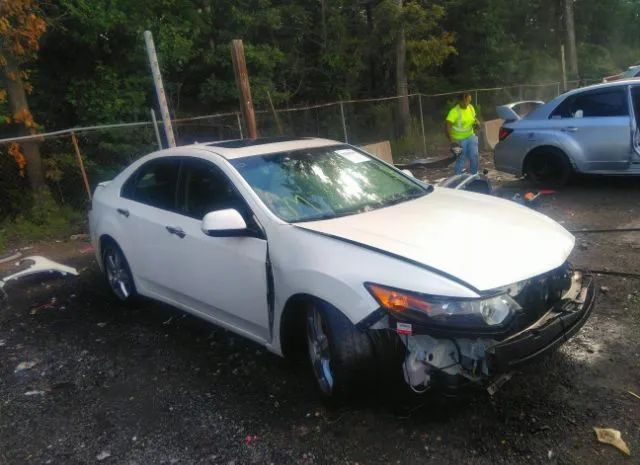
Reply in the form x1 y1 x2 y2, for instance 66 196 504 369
445 92 480 174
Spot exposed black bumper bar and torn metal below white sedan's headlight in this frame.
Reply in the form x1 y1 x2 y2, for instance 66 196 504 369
401 272 596 392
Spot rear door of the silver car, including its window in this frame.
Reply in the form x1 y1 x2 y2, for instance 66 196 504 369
550 86 633 171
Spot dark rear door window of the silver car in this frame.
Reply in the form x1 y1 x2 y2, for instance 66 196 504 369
550 87 629 119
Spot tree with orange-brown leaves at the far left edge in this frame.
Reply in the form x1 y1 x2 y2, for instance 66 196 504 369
0 0 46 192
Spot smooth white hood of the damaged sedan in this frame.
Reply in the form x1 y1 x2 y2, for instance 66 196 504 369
297 187 575 291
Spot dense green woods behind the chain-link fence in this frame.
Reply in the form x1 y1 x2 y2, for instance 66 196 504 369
0 0 640 231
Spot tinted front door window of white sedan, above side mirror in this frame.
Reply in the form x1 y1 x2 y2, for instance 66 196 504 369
178 158 247 220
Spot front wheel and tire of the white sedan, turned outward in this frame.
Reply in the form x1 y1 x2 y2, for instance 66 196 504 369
306 300 375 398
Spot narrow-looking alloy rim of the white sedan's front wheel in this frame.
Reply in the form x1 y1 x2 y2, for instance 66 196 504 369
307 306 333 395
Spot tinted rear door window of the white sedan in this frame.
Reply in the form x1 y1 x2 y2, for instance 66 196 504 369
121 158 180 210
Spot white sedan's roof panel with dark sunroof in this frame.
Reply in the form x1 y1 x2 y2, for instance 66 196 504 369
182 136 343 160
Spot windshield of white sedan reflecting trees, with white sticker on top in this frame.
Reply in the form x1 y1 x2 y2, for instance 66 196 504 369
231 146 429 222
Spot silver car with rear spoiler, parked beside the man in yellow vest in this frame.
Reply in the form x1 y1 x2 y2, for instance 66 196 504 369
494 79 640 186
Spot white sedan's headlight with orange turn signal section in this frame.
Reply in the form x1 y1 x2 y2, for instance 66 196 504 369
365 283 521 329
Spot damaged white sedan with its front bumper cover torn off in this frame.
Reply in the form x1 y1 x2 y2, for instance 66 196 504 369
90 138 594 395
